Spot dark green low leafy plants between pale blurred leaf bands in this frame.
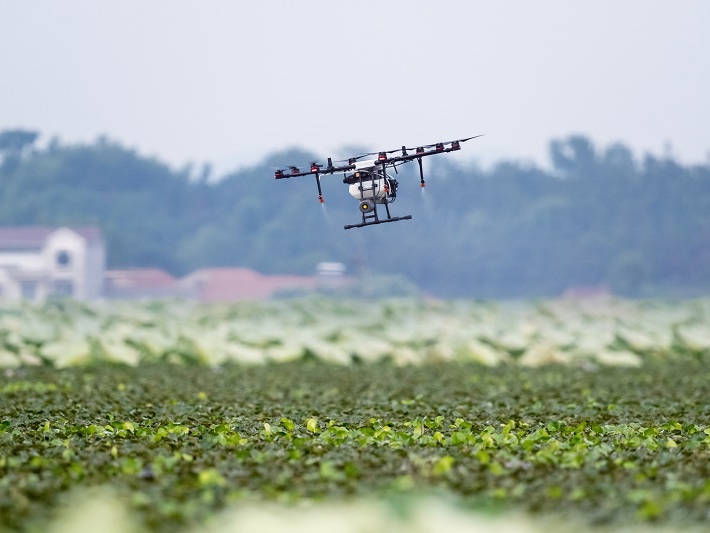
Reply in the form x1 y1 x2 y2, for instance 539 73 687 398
0 361 710 531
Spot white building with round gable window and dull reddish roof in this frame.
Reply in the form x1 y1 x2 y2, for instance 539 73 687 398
0 226 106 301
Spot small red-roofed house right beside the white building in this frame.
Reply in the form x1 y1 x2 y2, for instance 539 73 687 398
104 268 180 300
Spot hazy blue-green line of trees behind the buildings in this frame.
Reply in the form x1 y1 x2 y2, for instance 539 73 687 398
0 130 710 298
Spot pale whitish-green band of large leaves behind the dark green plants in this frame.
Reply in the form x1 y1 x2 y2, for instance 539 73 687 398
0 298 710 367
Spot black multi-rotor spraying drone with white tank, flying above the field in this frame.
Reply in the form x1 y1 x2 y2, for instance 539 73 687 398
274 135 481 229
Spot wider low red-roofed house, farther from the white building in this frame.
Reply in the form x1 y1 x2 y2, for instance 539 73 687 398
179 268 318 302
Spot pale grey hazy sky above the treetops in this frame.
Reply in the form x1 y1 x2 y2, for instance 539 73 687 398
0 0 710 172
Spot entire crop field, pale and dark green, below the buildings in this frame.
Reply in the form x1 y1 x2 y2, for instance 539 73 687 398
0 299 710 531
